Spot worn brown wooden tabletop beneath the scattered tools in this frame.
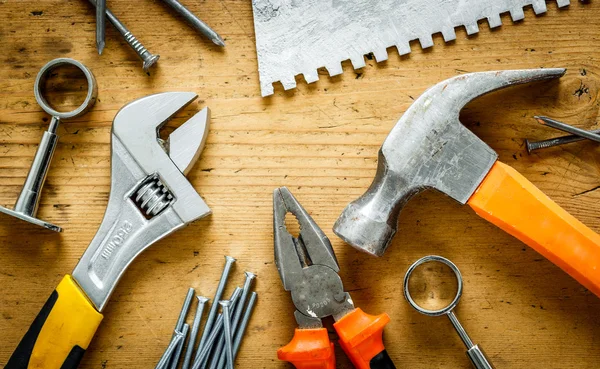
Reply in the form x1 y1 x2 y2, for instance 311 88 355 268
0 0 600 369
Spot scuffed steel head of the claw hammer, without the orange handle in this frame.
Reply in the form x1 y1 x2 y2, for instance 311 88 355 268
333 68 565 256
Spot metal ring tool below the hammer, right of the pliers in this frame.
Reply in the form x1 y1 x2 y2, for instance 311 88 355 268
404 255 494 369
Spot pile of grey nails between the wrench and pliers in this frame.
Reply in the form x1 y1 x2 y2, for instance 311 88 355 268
155 256 257 369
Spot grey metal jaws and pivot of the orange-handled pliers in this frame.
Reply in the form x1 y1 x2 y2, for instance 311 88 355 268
273 187 354 329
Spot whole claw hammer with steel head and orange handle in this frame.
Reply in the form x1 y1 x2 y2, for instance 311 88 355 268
333 68 600 296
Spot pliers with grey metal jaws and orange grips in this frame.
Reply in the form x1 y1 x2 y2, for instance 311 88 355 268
273 187 395 369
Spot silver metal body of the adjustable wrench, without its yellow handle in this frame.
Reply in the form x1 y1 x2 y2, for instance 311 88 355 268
73 92 210 311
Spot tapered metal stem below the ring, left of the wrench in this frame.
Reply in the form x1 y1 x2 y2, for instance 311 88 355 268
14 117 60 217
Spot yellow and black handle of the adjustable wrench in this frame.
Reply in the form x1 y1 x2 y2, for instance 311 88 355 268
4 275 103 369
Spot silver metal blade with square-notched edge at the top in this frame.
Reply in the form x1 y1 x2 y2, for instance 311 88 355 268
252 0 570 96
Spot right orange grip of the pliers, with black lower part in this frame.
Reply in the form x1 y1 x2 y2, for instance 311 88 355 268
333 308 390 369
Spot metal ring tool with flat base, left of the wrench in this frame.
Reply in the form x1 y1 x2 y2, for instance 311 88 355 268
0 58 98 232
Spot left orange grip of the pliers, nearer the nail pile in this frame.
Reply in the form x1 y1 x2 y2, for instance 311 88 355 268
277 328 335 369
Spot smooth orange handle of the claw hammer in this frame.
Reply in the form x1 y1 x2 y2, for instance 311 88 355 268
467 162 600 297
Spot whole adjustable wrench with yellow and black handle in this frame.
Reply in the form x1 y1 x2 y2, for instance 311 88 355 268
5 92 210 369
